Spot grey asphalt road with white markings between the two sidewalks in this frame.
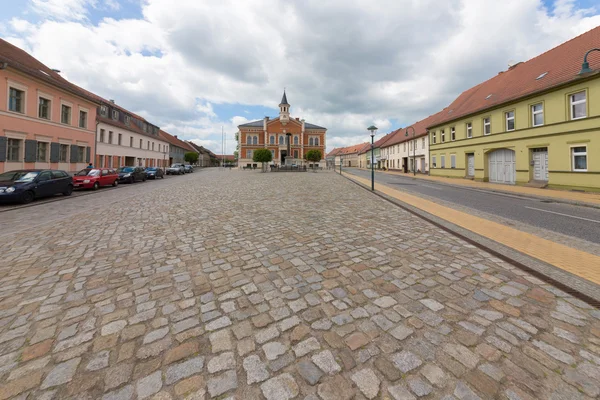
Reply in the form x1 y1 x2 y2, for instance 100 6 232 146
345 168 600 243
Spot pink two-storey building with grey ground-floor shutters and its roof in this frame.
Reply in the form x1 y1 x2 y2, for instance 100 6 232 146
0 39 99 173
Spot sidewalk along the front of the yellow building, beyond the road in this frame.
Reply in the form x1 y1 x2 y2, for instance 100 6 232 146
363 168 600 207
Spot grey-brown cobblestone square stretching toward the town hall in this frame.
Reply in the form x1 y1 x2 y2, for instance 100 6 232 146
0 170 600 400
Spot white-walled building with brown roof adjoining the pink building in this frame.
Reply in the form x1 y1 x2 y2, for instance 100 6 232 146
95 99 170 168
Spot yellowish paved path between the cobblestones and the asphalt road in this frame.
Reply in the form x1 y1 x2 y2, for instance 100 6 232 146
346 175 600 285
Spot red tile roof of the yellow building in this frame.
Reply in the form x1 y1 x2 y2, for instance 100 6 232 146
428 26 600 127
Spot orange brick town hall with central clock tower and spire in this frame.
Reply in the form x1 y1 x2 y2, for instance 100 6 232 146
238 91 327 168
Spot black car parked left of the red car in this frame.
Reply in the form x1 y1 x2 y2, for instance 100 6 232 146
0 169 73 203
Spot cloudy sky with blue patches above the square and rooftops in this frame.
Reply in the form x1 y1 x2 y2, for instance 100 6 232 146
0 0 600 154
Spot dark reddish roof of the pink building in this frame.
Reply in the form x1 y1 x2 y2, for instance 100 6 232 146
0 39 97 103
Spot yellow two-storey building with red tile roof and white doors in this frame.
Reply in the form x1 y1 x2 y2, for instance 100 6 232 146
428 27 600 190
